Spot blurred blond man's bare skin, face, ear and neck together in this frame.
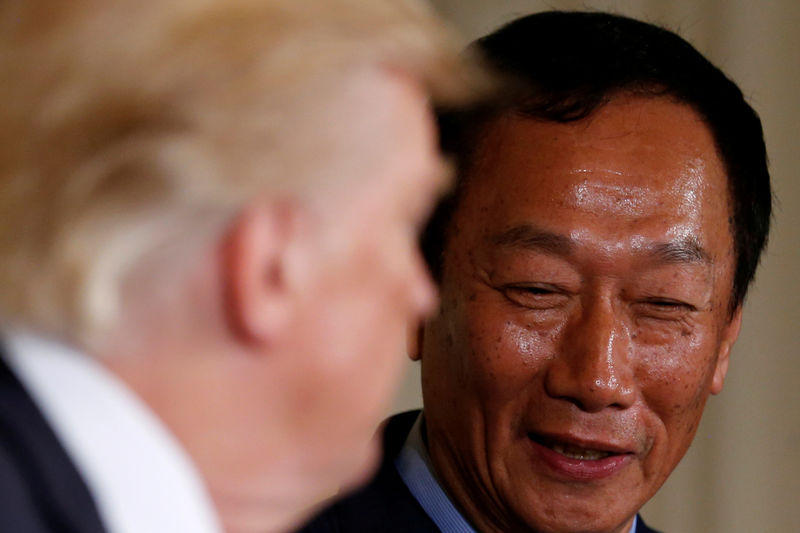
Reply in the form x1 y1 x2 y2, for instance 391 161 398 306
105 68 447 532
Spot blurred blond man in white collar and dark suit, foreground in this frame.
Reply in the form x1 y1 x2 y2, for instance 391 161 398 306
0 0 478 533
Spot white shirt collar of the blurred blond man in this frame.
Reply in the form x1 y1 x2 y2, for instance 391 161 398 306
4 333 222 533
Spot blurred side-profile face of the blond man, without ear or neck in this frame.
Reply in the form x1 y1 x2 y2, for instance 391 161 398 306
280 72 447 490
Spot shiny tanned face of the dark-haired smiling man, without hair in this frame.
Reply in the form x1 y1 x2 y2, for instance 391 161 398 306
421 96 740 532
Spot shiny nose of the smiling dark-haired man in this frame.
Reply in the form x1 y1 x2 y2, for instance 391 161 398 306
545 301 635 412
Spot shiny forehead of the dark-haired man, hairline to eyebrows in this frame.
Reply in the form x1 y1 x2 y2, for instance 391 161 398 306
446 97 732 270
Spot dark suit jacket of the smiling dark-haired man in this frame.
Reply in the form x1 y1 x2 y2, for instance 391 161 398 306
300 411 657 533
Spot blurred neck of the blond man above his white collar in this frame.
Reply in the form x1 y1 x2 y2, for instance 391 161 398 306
103 338 337 533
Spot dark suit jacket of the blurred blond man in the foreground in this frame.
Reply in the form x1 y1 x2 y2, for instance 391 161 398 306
0 354 106 533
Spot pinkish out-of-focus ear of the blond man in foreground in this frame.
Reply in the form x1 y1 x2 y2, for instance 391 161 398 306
221 198 298 345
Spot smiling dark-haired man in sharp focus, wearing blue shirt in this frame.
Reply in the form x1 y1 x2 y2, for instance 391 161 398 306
296 8 771 533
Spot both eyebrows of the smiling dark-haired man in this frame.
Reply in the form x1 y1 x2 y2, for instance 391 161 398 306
490 224 712 264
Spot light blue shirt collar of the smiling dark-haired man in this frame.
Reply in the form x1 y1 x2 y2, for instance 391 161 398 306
394 413 638 533
